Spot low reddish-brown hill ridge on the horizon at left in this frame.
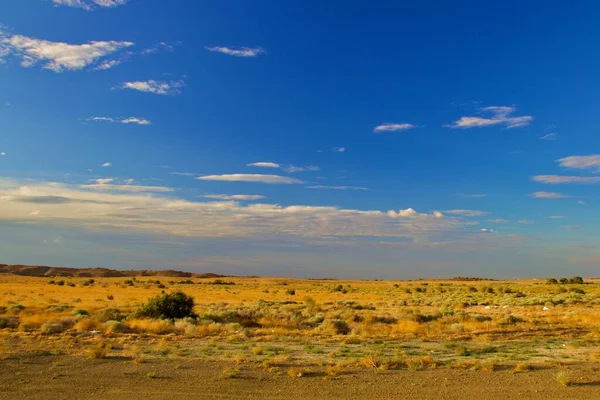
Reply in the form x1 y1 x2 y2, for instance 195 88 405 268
0 264 225 278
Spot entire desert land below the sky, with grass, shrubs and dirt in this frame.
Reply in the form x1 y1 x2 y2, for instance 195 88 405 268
0 266 600 399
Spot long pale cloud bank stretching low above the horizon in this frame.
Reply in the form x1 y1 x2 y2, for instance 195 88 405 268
0 178 470 244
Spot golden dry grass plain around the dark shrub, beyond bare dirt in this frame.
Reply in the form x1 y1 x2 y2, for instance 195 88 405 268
0 275 600 376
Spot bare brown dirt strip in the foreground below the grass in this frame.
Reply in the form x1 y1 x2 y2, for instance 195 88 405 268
0 355 600 400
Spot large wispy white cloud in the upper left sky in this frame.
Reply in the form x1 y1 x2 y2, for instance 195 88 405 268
0 35 134 72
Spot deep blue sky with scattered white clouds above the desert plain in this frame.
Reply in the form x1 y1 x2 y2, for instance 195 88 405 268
0 0 600 278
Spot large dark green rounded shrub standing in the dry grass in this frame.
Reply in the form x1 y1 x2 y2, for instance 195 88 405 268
135 291 197 319
